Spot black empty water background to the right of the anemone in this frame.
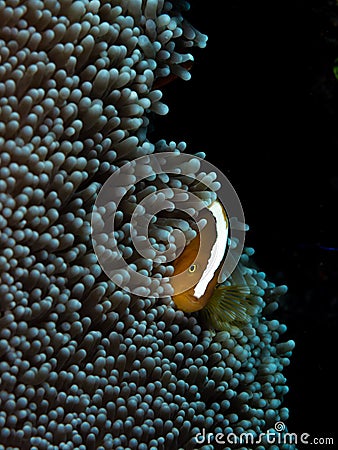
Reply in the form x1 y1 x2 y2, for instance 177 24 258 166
154 0 338 442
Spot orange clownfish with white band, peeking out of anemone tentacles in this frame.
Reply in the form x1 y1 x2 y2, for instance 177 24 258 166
172 200 254 330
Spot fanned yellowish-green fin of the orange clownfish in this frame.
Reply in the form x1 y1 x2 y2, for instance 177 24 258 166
200 285 256 331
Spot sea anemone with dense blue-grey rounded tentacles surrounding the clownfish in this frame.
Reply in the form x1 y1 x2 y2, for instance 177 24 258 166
0 0 294 450
